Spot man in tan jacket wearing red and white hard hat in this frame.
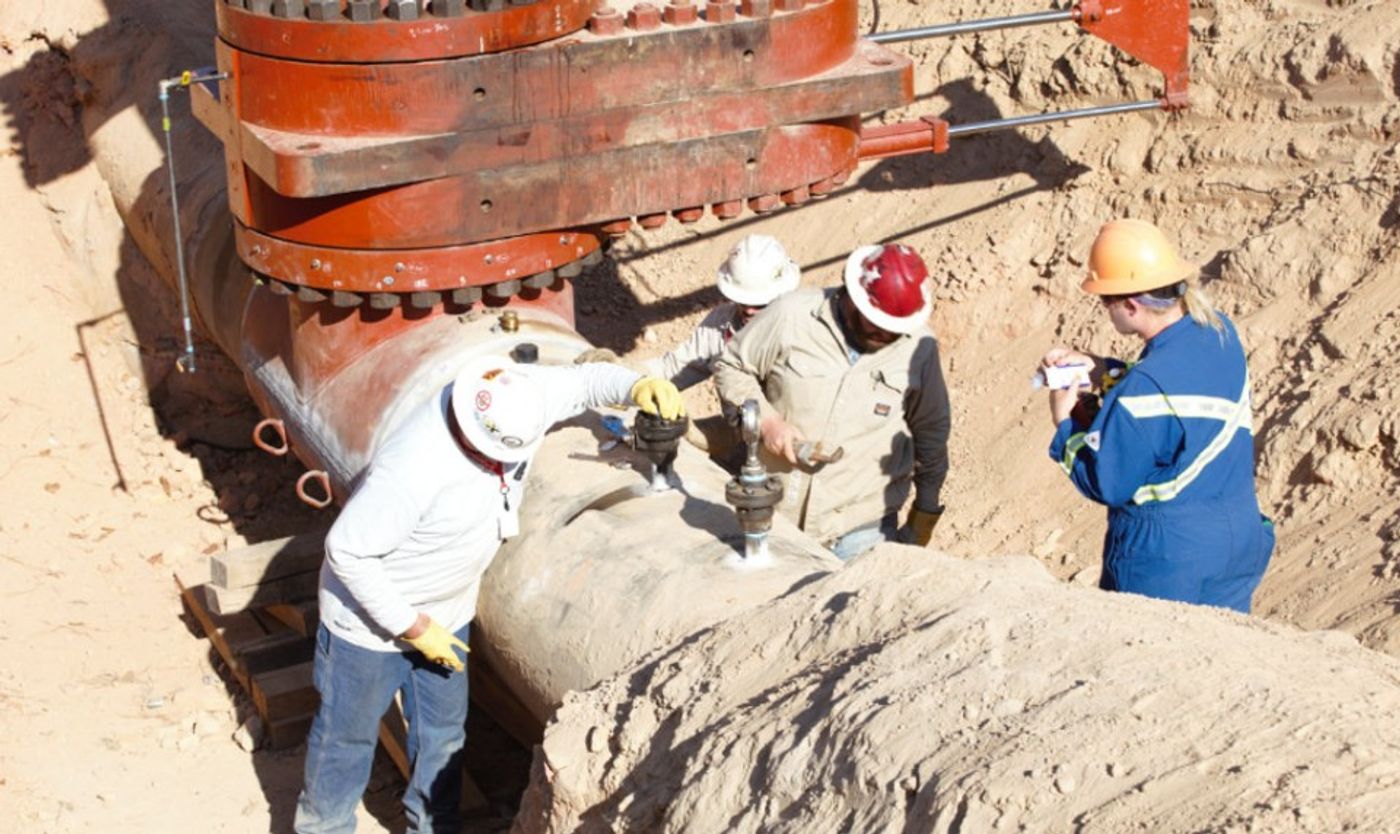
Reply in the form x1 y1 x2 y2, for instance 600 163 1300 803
715 237 949 558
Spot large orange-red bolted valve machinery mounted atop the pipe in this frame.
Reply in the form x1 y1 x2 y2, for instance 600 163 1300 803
193 0 1187 502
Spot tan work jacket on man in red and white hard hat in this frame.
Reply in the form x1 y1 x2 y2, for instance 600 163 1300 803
715 290 949 544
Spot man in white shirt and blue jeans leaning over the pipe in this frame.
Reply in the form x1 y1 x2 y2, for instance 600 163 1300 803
294 355 683 834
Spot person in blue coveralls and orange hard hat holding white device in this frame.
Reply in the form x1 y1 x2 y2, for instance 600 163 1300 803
1042 220 1274 613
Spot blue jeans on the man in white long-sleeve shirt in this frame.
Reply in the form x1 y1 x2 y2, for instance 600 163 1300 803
294 626 470 834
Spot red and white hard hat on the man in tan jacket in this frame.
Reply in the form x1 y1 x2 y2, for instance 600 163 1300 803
846 243 934 334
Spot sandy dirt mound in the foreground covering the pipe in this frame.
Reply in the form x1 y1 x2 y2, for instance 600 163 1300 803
514 546 1400 833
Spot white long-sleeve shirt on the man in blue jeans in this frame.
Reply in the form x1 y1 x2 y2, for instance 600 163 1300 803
319 364 638 651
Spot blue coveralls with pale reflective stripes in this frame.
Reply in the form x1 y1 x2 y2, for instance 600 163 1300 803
1050 316 1274 613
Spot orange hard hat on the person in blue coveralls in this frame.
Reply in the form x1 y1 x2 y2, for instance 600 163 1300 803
1079 220 1196 295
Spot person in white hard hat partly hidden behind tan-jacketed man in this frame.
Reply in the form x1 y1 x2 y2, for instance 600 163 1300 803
645 235 802 390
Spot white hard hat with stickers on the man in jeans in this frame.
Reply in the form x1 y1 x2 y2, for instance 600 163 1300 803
452 355 549 463
